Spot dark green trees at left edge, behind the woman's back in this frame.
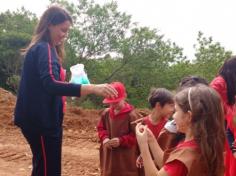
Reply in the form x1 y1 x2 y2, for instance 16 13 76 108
0 8 37 91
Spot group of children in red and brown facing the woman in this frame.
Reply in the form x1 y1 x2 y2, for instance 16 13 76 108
97 59 236 176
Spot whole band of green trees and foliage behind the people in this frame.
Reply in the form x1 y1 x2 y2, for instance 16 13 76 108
0 0 232 108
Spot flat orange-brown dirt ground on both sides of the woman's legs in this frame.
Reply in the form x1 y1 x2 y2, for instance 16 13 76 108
0 129 99 176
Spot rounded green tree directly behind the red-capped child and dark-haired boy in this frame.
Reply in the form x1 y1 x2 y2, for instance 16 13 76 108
104 27 185 107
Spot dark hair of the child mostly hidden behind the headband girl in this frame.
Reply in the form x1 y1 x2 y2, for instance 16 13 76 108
179 76 208 91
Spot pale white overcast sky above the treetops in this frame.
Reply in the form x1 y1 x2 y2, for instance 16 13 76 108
0 0 236 59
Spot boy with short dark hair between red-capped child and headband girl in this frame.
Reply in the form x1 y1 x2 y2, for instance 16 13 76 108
136 88 174 168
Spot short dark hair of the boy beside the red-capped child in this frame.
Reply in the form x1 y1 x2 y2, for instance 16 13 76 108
148 88 174 108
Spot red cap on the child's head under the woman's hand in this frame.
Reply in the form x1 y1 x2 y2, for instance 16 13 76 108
103 82 127 104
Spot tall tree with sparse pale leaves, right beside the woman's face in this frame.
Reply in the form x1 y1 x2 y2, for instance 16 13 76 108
51 0 131 61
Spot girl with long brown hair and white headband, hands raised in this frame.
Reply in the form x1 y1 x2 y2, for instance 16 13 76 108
136 85 225 176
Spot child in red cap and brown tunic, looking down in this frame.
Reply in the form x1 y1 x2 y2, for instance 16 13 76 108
97 82 141 176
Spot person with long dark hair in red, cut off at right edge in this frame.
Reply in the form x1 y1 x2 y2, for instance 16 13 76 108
210 56 236 176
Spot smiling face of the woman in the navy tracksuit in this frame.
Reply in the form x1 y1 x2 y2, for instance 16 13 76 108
49 21 71 46
